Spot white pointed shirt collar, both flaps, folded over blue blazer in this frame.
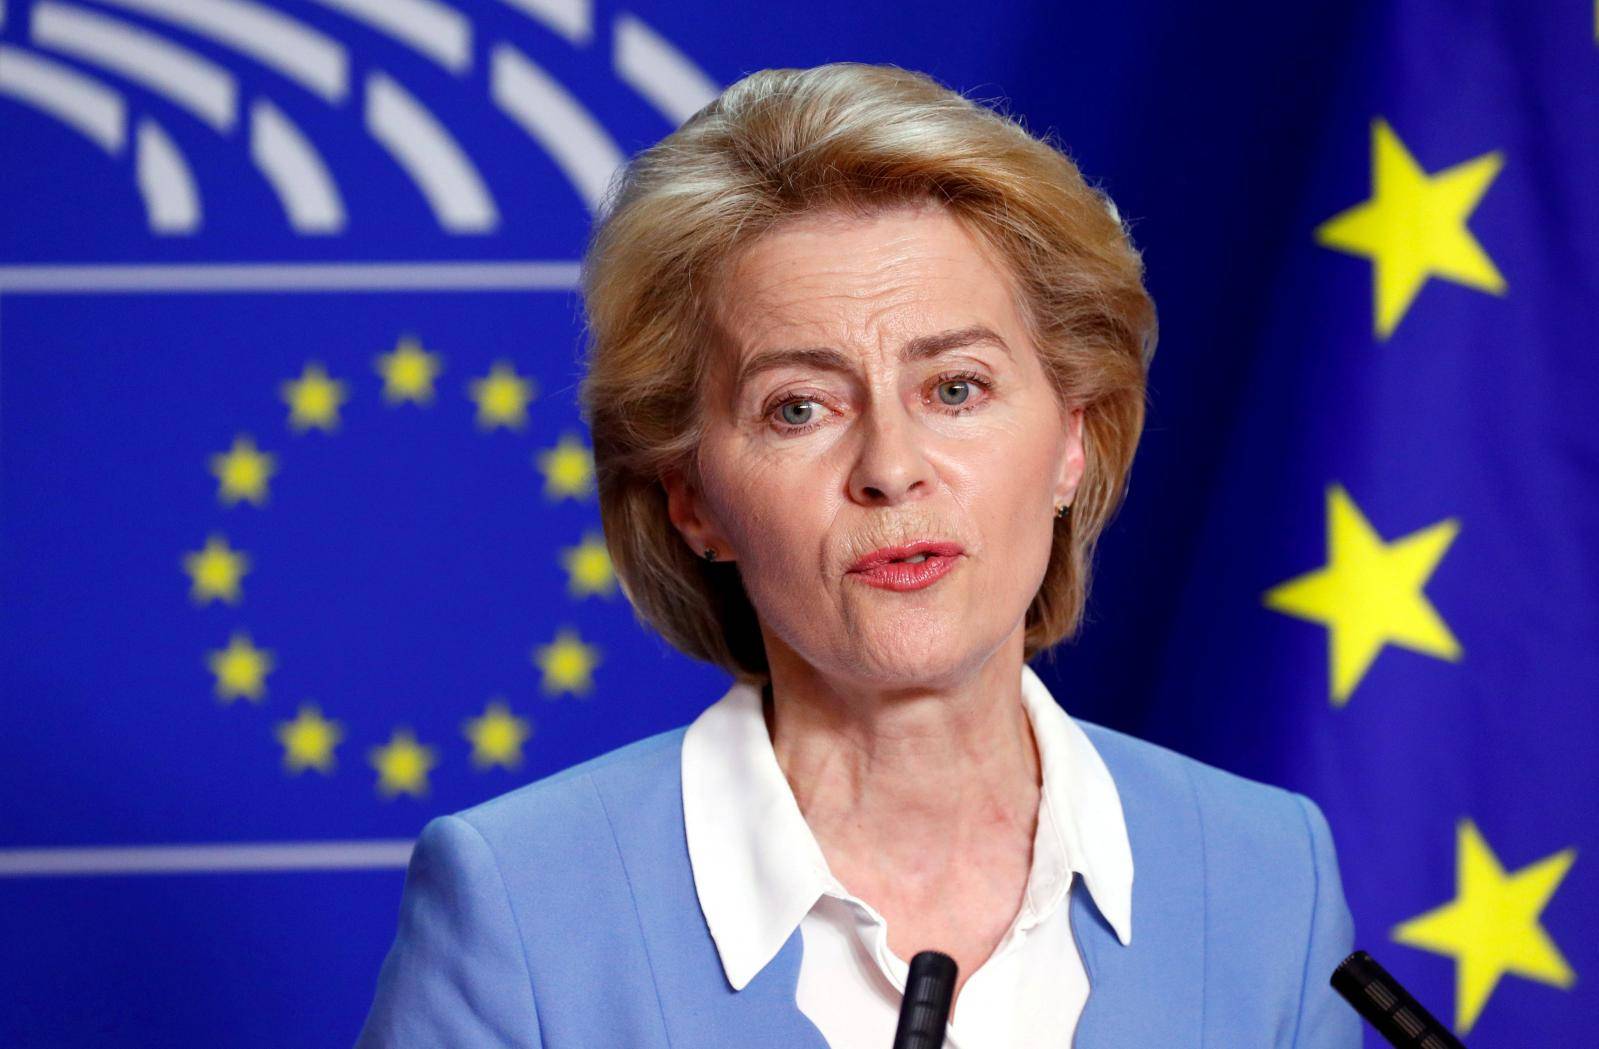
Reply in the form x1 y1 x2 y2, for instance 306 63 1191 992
681 665 1132 990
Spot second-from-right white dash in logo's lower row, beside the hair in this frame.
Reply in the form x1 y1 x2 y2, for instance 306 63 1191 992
489 43 622 211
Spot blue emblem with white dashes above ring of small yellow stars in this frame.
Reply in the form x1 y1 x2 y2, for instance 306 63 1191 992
0 0 718 873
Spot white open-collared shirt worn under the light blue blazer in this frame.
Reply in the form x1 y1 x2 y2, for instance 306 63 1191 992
683 665 1132 1049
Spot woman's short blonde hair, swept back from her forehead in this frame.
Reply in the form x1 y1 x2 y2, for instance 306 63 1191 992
580 62 1156 683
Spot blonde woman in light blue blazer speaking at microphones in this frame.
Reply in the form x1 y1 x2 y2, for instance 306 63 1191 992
361 64 1359 1049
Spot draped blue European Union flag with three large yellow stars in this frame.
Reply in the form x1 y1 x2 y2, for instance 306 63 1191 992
1100 3 1599 1046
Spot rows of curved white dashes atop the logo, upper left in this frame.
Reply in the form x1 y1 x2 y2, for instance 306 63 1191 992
0 0 715 235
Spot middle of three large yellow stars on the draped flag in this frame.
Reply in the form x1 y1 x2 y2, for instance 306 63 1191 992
1263 485 1460 707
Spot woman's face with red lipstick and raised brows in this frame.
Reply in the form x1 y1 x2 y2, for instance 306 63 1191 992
665 206 1083 688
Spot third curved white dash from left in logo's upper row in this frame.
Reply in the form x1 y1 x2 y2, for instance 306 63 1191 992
90 0 350 102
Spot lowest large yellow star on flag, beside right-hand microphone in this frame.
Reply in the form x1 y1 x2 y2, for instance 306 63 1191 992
1393 819 1577 1035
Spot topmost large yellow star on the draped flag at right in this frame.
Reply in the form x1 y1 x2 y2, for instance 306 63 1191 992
1316 117 1505 339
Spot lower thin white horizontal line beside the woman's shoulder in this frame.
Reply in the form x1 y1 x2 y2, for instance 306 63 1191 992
0 838 414 878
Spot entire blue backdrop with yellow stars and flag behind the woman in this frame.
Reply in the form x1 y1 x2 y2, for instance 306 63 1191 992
0 0 1599 1049
